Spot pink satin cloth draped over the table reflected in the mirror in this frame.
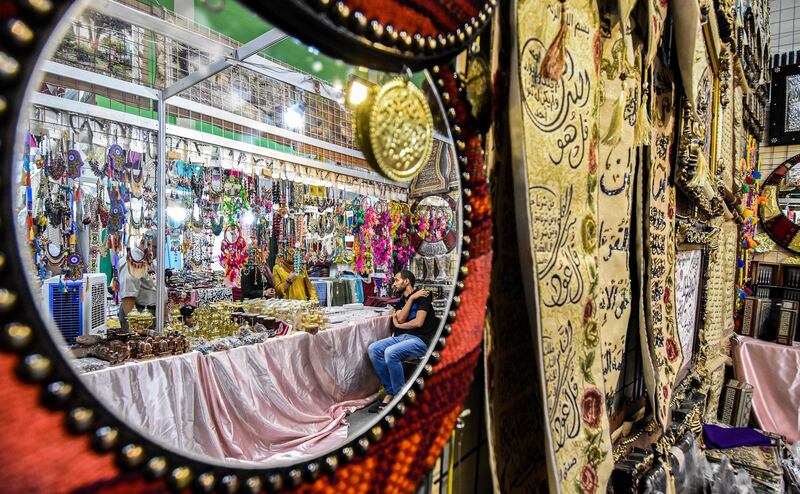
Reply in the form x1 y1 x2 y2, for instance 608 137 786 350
82 315 391 466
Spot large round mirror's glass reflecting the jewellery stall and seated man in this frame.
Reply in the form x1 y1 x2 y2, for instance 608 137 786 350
16 0 461 466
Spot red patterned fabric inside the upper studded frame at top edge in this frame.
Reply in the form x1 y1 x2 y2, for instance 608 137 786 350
344 0 485 36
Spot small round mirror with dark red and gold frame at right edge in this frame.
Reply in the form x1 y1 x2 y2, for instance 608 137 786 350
759 155 800 253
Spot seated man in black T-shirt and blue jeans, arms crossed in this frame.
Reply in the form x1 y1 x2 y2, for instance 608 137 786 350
369 270 439 413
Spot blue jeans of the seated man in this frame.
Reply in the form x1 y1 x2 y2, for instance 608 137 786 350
369 334 428 396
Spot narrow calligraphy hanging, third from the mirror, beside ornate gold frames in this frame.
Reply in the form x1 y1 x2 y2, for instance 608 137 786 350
641 58 683 428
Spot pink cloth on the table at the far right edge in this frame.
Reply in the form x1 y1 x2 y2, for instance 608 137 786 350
733 336 800 443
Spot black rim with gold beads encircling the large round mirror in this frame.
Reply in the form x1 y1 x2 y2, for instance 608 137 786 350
0 0 491 493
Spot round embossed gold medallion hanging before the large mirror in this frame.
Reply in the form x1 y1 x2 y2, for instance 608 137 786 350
354 77 433 181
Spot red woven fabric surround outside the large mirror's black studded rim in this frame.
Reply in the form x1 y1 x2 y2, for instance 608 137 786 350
0 66 492 494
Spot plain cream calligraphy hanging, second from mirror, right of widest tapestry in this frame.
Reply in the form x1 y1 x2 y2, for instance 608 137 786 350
597 16 640 408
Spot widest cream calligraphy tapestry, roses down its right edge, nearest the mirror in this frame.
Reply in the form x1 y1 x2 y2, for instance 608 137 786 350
512 0 613 494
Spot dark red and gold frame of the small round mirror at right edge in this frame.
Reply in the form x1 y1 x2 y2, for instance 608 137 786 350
758 154 800 254
